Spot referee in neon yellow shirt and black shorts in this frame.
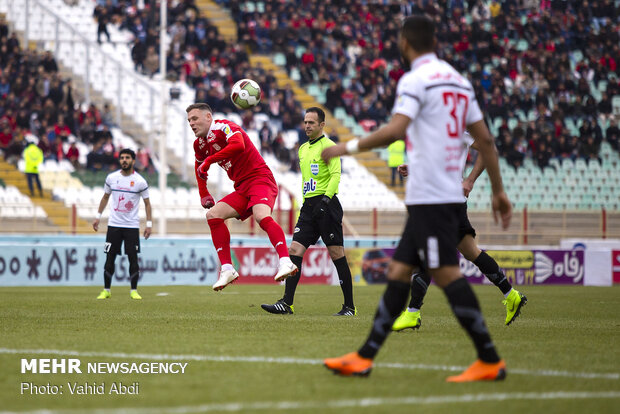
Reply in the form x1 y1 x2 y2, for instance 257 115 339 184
261 107 357 316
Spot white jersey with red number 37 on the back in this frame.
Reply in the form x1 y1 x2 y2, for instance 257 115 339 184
392 53 482 205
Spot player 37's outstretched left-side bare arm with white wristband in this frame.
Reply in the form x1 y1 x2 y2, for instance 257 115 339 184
321 114 411 163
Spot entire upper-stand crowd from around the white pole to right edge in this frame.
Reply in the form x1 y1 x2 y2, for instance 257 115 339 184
34 0 620 175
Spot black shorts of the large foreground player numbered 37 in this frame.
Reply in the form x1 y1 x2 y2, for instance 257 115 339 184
393 203 463 270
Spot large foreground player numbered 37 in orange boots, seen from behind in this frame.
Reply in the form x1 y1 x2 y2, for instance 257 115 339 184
322 16 512 382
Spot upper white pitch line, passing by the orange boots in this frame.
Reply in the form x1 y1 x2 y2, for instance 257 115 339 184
0 348 620 380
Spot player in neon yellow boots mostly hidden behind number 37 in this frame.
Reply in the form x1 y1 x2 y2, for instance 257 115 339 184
392 133 527 331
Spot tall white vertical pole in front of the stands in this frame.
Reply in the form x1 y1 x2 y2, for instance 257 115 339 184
159 0 168 236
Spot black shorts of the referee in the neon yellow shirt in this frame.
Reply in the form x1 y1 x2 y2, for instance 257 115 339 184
293 195 344 249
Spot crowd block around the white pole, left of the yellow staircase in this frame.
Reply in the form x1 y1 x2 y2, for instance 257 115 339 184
94 0 305 168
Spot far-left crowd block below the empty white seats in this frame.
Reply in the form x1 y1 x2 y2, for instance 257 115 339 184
0 20 131 170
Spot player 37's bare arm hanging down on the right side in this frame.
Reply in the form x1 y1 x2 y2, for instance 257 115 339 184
467 121 512 229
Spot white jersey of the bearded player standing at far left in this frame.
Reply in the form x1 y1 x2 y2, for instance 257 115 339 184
103 170 149 229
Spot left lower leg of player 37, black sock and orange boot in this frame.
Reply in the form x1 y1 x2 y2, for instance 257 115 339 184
323 260 414 376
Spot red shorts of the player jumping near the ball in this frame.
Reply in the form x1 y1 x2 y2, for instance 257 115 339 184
220 176 278 221
